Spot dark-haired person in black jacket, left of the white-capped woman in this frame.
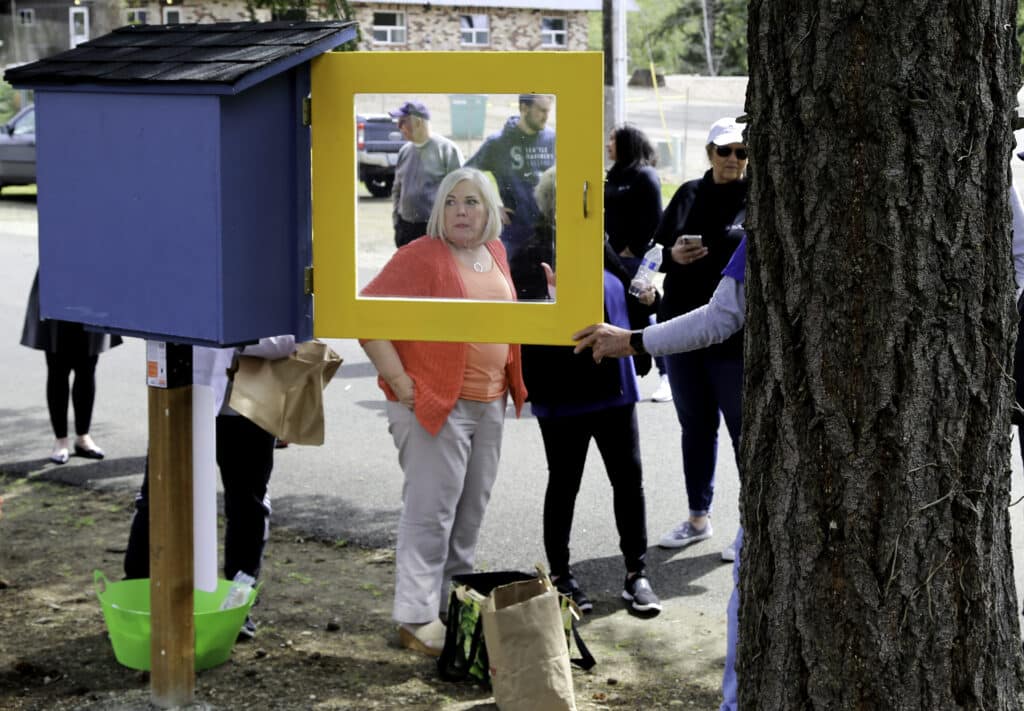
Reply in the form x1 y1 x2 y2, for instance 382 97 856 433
604 124 672 403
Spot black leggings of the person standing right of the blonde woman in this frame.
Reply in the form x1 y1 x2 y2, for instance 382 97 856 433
537 404 647 576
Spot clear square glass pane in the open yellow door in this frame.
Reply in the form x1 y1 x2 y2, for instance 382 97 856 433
354 94 556 301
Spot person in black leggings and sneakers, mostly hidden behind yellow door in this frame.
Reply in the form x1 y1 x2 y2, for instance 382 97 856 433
512 168 662 615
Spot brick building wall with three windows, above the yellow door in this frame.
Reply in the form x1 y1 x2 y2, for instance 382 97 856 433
351 2 588 51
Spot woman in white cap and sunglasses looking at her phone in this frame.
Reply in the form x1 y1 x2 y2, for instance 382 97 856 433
654 118 748 560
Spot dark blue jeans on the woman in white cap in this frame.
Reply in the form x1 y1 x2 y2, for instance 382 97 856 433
665 349 743 516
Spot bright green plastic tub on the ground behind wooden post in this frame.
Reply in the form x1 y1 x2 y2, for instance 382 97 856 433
93 571 259 671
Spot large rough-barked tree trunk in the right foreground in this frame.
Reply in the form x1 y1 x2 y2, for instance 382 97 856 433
738 0 1024 711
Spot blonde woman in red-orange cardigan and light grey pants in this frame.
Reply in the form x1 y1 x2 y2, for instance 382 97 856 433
362 168 526 656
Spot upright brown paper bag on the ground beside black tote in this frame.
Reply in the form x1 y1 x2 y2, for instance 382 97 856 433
480 578 577 711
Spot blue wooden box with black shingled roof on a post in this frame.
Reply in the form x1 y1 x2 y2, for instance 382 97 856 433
5 23 355 345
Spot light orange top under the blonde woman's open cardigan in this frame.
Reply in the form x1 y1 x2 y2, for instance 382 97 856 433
455 259 512 403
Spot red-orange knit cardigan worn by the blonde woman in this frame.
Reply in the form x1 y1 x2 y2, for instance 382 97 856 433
360 237 526 436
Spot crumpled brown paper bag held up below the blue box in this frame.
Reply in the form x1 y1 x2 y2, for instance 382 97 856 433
228 340 341 445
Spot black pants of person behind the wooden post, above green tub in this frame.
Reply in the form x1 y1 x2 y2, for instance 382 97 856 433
125 415 274 580
